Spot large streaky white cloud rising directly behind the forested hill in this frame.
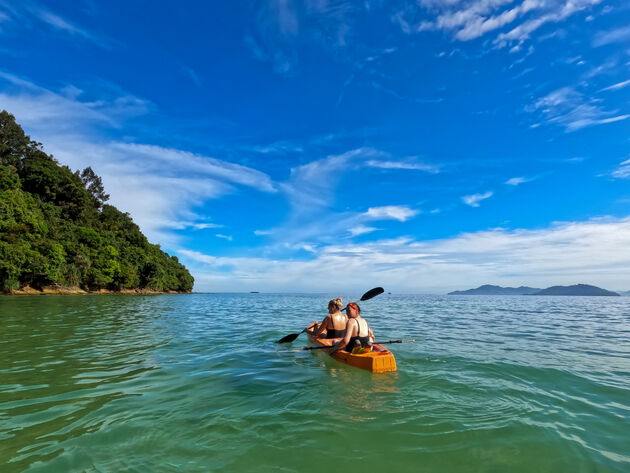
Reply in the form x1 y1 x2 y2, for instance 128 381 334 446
0 73 276 247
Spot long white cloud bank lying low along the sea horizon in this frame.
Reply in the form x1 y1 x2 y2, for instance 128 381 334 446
179 217 630 292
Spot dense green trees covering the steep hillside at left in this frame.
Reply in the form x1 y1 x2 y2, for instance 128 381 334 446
0 111 194 291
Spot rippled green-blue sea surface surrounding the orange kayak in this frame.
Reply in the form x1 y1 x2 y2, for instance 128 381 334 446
0 294 630 473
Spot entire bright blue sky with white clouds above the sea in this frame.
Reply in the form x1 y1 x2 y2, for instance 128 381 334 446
0 0 630 292
